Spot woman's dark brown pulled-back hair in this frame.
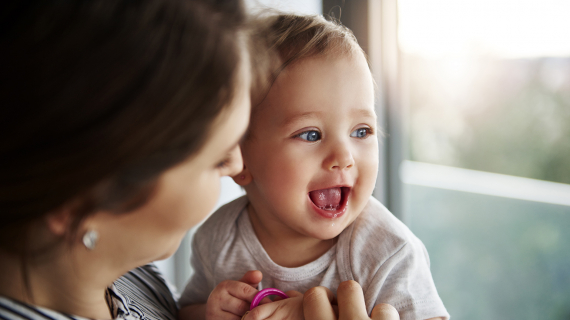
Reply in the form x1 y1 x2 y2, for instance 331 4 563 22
0 0 245 255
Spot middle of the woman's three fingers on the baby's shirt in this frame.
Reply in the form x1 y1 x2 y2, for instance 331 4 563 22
336 280 370 320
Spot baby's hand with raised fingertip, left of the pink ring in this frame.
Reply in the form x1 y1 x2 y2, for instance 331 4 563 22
206 271 262 320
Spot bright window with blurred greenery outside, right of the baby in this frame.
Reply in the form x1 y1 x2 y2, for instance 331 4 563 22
397 0 570 319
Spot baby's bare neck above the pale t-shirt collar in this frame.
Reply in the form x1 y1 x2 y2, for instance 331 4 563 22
248 204 337 268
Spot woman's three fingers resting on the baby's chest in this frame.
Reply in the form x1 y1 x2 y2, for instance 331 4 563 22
303 280 400 320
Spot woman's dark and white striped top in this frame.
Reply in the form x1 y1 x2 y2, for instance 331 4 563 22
0 264 178 320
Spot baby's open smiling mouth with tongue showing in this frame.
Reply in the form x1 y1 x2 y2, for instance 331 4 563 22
307 187 351 219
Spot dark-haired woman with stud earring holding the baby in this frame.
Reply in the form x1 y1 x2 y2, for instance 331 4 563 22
0 0 398 319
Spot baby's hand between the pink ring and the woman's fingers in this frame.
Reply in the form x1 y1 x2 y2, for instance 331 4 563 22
243 291 305 320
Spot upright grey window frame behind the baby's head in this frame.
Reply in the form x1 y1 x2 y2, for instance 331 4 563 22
323 0 409 223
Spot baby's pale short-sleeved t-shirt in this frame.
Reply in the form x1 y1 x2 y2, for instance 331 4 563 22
180 196 449 320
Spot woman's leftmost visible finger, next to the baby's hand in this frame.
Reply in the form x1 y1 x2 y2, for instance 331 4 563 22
303 287 337 320
